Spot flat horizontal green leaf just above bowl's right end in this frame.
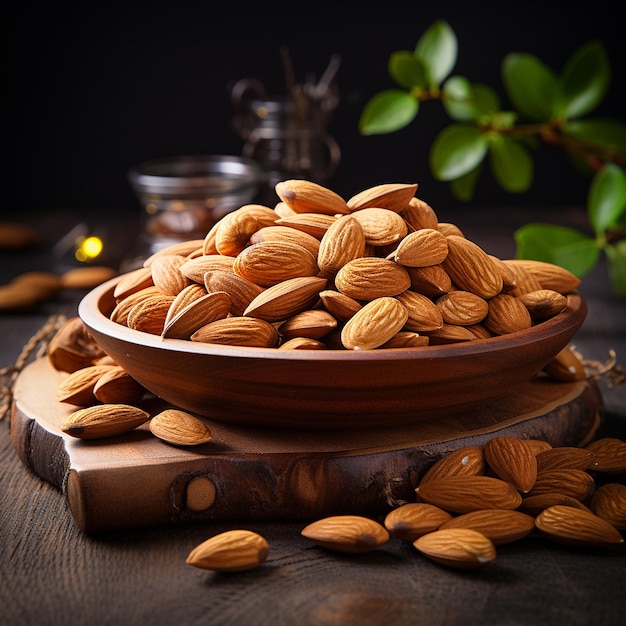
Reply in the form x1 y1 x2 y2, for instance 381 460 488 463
514 222 600 278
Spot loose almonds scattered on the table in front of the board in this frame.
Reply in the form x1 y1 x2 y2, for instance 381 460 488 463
187 436 626 572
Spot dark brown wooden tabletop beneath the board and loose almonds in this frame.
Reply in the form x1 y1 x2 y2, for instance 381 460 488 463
0 208 626 626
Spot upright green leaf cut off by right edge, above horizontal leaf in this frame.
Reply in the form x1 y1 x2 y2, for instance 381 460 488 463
587 163 626 235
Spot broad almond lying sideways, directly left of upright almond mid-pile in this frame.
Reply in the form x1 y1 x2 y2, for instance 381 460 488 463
233 241 319 287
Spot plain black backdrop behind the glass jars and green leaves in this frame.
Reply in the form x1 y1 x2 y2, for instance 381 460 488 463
2 1 625 219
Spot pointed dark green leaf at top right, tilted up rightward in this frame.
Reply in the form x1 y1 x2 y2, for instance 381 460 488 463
555 41 611 119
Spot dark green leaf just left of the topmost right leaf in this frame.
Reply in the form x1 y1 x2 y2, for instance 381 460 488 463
502 53 557 121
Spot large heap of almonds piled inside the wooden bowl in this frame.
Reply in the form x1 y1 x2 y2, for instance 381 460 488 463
103 180 580 350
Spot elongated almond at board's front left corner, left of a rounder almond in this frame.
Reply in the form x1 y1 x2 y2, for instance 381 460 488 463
61 404 150 439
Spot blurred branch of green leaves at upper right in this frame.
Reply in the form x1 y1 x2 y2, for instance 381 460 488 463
359 20 626 296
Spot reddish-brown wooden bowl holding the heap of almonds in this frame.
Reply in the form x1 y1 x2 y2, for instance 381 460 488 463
78 278 587 430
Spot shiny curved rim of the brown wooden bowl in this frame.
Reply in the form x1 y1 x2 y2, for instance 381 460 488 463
78 275 587 363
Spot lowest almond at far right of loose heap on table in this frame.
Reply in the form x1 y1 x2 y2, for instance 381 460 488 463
535 504 624 548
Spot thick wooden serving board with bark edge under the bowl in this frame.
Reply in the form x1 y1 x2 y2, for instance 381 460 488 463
11 358 603 533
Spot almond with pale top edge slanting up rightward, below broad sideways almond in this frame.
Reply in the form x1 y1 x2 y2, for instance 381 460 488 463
243 276 327 322
